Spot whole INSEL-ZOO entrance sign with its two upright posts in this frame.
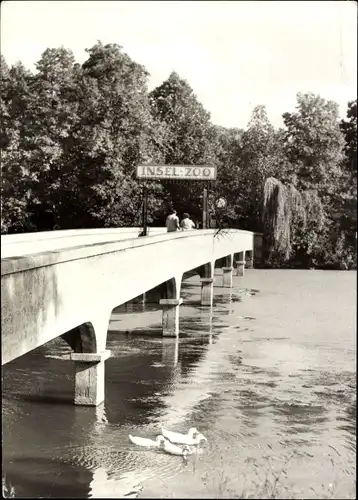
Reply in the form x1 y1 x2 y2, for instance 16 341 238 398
136 165 216 236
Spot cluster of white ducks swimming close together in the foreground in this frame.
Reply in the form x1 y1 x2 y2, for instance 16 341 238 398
129 427 207 457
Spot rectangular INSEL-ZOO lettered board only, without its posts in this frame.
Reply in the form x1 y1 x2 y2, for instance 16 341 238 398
137 165 216 181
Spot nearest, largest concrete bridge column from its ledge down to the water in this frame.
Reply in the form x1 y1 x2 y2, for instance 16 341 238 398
71 350 111 406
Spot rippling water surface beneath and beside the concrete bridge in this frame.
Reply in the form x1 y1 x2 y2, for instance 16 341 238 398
3 270 357 498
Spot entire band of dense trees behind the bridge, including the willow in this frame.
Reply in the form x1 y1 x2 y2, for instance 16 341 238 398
0 42 357 268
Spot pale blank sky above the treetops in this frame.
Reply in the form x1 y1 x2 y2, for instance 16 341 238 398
1 1 357 127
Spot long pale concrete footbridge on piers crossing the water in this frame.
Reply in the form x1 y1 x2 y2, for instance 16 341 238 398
1 228 255 405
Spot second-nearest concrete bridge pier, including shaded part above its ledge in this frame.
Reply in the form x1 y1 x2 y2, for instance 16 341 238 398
159 277 183 337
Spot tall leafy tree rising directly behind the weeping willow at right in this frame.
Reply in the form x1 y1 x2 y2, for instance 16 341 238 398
276 94 345 266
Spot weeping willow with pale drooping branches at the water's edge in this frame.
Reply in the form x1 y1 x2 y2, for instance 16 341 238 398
262 177 324 266
